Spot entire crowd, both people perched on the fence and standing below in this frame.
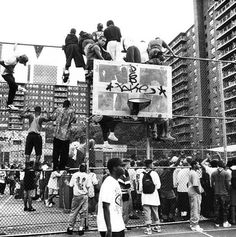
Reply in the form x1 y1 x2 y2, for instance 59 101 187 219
0 20 236 237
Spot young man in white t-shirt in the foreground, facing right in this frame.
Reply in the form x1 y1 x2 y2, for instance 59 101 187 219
97 158 125 237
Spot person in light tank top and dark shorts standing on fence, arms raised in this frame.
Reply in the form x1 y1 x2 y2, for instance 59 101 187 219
20 106 50 168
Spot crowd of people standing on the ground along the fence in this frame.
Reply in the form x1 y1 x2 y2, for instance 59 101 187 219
0 152 236 236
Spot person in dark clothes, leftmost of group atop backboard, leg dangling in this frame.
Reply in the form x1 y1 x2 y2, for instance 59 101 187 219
63 28 85 82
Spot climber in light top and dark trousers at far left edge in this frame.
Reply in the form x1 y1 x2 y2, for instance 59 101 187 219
0 45 29 110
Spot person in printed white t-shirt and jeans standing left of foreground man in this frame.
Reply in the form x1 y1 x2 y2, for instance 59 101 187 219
65 164 92 235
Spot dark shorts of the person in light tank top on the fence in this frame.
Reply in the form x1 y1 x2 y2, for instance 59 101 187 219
25 132 43 156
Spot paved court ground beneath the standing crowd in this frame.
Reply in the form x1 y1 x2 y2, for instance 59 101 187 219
0 187 236 237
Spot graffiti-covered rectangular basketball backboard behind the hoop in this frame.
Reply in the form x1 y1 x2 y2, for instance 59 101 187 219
93 60 172 118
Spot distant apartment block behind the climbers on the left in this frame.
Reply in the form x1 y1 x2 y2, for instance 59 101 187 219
0 82 87 130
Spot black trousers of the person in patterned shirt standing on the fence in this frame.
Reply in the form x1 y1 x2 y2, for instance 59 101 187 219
52 137 70 170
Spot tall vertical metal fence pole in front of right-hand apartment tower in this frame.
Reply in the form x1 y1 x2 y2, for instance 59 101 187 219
218 63 228 163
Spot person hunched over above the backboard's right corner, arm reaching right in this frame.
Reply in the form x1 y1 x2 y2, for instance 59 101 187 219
147 37 175 64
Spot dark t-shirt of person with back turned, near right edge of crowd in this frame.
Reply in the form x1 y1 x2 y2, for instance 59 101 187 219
211 169 230 195
